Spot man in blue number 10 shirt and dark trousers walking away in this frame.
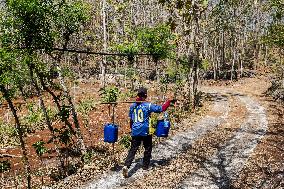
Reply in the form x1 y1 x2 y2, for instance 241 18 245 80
122 87 175 178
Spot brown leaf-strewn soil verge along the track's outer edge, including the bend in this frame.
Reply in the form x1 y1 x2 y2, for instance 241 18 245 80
203 77 284 189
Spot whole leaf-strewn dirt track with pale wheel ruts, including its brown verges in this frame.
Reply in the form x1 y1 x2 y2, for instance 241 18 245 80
48 76 284 189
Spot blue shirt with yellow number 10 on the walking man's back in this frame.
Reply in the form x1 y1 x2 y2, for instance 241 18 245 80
129 102 162 136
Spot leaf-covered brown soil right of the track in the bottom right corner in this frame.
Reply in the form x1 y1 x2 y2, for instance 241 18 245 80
234 97 284 189
